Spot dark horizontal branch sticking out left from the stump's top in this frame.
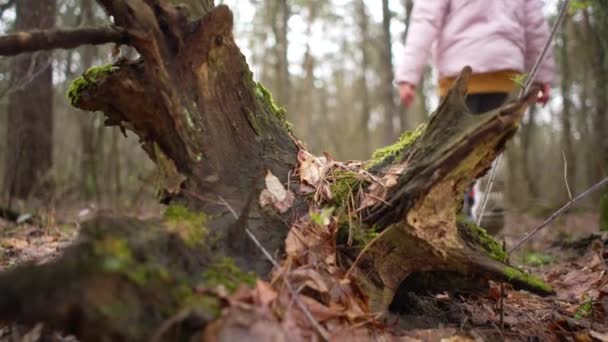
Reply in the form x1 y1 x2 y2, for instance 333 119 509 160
0 26 129 56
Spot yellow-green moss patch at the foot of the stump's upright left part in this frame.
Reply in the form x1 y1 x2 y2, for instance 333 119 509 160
164 204 208 247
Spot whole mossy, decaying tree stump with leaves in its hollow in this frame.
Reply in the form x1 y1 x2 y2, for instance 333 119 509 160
0 0 552 341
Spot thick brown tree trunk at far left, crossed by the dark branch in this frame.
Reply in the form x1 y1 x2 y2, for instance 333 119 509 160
4 0 55 198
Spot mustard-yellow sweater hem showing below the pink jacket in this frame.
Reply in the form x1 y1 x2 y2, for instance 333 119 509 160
438 70 520 97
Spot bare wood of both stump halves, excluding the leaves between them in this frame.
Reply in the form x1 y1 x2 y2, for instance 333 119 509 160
0 0 551 341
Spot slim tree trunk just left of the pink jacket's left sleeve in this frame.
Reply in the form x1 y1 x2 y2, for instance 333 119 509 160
381 0 396 144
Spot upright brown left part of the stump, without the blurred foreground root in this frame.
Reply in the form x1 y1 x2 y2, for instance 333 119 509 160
70 1 297 273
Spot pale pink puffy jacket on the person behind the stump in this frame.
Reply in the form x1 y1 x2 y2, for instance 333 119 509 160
396 0 555 85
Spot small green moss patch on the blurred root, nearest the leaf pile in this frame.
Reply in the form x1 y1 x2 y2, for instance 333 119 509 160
202 257 256 292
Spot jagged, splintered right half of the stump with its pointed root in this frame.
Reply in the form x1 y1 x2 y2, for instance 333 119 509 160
344 68 552 311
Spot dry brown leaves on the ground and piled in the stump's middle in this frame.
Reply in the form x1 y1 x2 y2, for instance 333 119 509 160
0 151 608 342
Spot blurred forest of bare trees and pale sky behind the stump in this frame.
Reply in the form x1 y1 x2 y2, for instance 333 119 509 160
0 0 608 219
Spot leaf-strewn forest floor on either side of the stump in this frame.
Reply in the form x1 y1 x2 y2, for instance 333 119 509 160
0 208 608 341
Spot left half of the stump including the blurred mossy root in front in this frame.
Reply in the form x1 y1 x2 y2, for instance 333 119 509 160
0 0 306 341
